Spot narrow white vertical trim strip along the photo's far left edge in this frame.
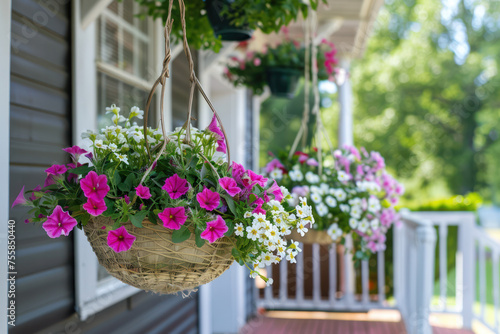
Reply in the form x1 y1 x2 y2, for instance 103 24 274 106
0 0 12 333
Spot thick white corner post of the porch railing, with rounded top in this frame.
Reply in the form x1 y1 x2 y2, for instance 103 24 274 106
414 221 436 334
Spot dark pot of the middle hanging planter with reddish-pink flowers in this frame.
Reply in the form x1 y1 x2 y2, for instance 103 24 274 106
267 67 302 99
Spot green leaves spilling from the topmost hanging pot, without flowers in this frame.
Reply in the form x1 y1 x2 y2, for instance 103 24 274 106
136 0 325 52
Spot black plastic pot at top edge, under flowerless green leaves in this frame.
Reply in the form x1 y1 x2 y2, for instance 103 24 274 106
205 0 253 42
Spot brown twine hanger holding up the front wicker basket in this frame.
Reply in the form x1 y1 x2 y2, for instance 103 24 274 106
141 0 231 184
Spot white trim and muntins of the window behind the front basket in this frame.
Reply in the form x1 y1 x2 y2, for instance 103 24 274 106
71 0 167 321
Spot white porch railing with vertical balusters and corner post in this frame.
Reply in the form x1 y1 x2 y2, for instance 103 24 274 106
257 211 500 334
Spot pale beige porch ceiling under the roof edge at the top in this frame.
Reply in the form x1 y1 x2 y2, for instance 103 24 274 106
249 0 383 58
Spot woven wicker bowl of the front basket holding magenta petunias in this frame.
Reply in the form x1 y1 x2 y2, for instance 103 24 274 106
84 217 234 294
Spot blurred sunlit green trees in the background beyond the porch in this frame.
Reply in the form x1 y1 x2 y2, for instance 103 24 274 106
260 0 500 207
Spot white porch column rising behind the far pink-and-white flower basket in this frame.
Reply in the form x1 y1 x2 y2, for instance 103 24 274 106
338 58 354 147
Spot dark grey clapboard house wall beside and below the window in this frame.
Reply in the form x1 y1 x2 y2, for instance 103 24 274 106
9 0 198 334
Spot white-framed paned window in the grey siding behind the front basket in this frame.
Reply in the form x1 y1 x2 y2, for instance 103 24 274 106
73 0 162 320
